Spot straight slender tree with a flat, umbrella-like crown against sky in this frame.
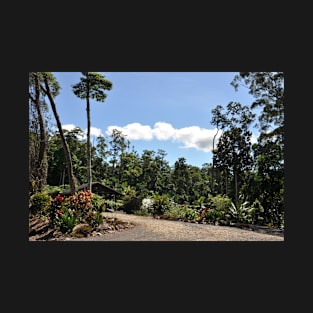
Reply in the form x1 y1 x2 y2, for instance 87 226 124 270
72 72 112 190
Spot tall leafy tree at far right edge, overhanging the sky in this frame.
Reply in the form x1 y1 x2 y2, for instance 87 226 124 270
232 72 285 224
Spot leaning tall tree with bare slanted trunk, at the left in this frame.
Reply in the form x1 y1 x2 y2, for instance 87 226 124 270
38 72 76 195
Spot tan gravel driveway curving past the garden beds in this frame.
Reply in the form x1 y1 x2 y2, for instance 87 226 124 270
67 212 284 241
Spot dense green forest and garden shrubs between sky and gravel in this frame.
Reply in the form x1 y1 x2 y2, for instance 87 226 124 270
29 72 284 239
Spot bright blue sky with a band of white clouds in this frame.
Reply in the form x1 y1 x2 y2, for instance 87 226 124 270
53 72 257 167
